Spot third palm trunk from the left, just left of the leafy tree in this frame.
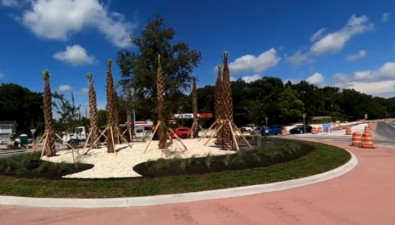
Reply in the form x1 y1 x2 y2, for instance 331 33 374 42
106 59 115 153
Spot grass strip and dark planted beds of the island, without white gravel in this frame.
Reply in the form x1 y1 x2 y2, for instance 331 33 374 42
0 138 351 198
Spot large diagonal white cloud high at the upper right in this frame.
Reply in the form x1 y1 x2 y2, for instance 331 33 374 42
310 15 373 55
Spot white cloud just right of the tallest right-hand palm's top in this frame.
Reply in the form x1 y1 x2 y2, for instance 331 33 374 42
229 48 281 73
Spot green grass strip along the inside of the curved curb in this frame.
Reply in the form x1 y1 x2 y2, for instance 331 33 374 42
0 141 351 198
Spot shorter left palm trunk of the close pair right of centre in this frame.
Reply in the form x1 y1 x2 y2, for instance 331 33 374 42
214 65 223 145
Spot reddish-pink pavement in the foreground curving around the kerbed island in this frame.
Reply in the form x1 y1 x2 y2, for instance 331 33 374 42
0 140 395 225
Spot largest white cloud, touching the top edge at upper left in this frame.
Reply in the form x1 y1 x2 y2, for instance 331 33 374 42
22 0 133 47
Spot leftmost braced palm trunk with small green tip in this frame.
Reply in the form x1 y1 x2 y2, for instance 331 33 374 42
41 70 56 157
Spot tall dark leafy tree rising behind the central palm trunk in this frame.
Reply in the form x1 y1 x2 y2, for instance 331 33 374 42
117 16 201 119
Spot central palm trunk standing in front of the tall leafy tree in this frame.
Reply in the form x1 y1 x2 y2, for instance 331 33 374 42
156 55 167 149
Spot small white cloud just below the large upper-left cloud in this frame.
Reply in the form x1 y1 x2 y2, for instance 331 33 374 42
53 45 95 66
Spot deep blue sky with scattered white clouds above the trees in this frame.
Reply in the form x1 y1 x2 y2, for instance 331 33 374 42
0 0 395 112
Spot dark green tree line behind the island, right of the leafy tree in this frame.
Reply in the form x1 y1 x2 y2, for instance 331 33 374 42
198 77 395 125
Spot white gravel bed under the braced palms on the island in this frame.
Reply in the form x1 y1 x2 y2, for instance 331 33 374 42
43 139 235 178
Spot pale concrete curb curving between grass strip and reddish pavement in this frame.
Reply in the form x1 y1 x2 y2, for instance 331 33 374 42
0 151 358 208
